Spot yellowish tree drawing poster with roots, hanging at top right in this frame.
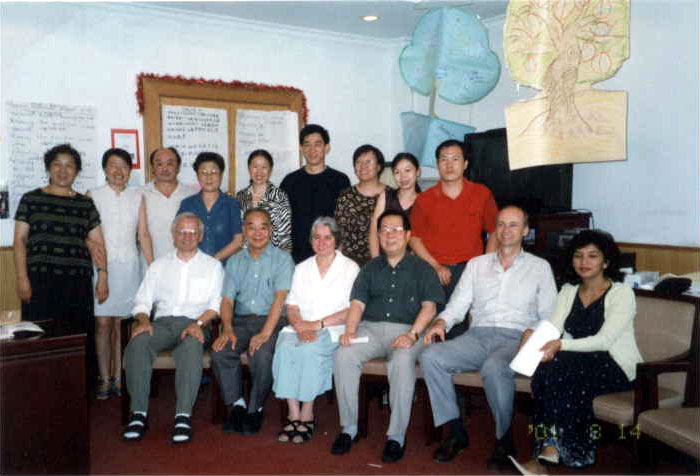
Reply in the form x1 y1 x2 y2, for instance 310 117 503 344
503 0 630 170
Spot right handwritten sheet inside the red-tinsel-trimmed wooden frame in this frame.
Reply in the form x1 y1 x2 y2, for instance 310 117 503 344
236 109 299 190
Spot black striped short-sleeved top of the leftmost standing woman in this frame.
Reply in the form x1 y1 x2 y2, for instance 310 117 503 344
15 188 100 276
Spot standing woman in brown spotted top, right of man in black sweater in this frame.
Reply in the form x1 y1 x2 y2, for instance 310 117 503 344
335 144 386 266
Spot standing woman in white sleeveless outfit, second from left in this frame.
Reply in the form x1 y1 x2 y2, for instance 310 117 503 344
88 149 153 400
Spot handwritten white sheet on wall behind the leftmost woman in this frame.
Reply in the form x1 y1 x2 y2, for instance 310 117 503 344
3 101 102 219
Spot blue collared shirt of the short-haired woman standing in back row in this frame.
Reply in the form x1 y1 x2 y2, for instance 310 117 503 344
177 192 242 266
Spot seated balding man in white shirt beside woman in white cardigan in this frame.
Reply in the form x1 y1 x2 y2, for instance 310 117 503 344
419 206 557 471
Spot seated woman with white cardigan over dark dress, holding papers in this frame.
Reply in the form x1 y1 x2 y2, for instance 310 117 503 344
517 230 642 474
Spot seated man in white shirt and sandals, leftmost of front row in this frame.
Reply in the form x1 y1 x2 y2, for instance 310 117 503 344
122 213 224 443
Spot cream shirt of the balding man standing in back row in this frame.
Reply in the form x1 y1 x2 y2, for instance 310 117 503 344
143 182 197 259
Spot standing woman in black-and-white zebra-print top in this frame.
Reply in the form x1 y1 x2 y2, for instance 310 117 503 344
236 149 292 252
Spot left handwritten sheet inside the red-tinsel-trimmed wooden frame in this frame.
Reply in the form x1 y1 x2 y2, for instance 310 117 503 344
162 104 229 191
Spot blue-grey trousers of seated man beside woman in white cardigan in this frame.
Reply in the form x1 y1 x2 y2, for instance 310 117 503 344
420 327 521 438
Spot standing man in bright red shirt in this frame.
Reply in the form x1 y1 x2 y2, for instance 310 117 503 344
410 139 498 337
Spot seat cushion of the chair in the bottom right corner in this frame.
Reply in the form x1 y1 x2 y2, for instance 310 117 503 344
639 408 700 459
